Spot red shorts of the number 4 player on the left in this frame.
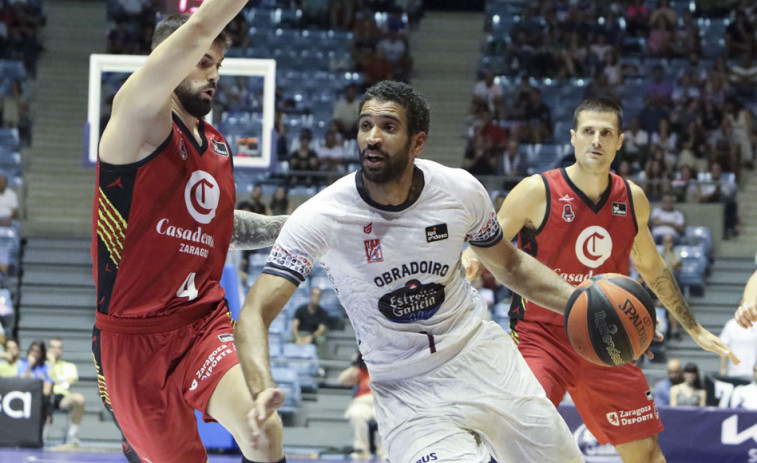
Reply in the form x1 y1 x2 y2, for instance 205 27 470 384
92 304 239 463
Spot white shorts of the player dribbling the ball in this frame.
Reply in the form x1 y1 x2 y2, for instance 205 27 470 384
371 321 583 463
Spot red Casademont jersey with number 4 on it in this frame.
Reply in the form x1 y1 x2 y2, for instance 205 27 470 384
92 115 235 321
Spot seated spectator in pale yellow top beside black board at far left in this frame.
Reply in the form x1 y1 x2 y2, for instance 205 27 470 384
47 338 84 445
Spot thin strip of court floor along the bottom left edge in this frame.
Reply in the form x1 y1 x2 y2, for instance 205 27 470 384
0 448 379 463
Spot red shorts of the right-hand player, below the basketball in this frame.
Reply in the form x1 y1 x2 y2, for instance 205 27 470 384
513 320 663 445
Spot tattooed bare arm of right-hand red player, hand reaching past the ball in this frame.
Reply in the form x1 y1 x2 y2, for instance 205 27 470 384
629 182 739 364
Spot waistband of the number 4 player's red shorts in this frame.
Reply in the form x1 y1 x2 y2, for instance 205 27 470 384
95 304 219 334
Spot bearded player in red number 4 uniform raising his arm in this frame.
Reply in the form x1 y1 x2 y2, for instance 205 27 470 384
92 0 286 463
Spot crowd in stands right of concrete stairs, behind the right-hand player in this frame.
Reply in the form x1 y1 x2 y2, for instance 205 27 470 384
463 0 757 245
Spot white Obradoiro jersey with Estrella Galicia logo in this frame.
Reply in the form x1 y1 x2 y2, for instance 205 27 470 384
263 160 502 380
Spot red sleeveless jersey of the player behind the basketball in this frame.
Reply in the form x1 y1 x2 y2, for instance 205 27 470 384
510 169 638 325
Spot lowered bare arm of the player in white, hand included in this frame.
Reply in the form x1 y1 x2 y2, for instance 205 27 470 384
234 273 297 445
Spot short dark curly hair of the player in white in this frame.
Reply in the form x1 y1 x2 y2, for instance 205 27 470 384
360 80 431 137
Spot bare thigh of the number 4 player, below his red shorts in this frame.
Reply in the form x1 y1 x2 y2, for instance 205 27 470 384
206 364 282 461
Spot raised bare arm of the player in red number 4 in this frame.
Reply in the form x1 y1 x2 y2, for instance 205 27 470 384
100 0 247 164
